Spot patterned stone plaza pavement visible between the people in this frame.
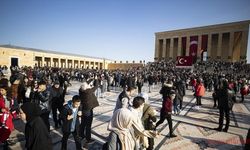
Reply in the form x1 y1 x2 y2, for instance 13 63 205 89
4 81 250 150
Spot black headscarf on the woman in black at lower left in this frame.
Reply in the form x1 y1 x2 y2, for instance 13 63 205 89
21 102 41 122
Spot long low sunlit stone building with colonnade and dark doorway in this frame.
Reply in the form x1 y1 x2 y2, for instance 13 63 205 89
0 45 112 69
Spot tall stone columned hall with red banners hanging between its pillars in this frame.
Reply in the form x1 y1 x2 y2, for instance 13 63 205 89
154 20 250 62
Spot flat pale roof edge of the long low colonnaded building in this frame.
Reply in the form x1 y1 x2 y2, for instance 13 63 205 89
0 44 110 60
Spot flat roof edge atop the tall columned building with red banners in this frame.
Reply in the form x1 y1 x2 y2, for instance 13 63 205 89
155 20 250 35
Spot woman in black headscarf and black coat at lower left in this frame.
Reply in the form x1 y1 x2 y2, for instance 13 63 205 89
20 102 52 150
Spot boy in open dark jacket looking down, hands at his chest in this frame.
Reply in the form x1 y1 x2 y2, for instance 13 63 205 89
61 95 82 150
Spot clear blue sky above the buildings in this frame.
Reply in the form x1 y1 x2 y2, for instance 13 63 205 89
0 0 250 61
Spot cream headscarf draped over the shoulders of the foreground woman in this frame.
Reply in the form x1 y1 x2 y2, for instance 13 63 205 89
108 108 135 150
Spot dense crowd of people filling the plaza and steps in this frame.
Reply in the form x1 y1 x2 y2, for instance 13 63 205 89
0 60 250 150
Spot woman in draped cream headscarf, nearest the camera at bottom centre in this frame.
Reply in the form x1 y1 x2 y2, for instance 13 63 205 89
103 108 158 150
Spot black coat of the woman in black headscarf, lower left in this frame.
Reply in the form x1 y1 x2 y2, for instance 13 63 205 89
25 116 52 150
